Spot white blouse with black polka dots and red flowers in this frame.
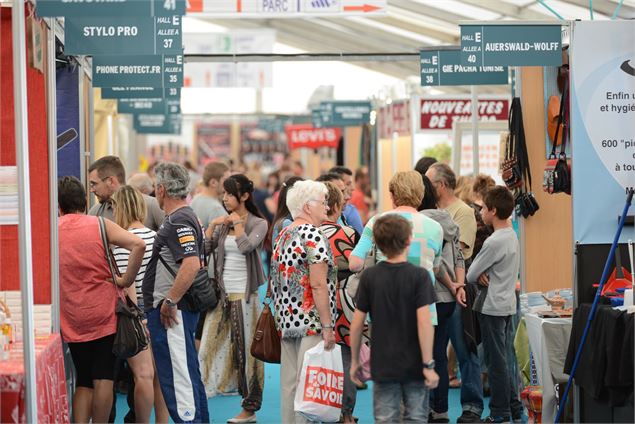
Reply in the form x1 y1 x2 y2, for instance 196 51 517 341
269 224 337 339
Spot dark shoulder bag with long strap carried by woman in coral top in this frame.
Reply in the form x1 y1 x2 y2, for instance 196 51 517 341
98 216 149 359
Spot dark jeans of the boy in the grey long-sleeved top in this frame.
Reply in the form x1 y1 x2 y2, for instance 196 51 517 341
479 314 523 417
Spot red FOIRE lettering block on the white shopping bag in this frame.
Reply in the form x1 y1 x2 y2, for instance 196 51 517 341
304 366 344 408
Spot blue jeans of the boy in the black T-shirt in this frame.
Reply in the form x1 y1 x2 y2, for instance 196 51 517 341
373 380 430 424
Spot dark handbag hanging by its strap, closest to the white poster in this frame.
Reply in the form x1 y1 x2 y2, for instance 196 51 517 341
542 77 571 194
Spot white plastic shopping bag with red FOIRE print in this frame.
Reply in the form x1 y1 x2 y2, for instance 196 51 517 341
294 341 344 422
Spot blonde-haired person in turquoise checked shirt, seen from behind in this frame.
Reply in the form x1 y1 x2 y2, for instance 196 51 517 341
349 171 443 325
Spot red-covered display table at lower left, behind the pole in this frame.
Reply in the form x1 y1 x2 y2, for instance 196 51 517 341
0 334 70 423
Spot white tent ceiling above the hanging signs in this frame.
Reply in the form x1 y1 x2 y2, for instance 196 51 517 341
192 0 635 92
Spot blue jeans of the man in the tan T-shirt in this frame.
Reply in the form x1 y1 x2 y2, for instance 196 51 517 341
450 303 483 415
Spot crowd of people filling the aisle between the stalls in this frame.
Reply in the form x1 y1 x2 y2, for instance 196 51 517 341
58 156 523 423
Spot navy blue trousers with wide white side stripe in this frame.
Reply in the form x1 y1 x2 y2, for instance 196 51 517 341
147 308 209 423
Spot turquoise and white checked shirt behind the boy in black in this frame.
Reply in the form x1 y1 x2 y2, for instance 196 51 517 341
352 211 443 325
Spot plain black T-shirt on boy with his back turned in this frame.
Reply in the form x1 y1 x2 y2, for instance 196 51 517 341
356 262 436 383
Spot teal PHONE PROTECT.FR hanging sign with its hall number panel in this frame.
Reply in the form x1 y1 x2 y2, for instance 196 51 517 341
93 54 183 88
